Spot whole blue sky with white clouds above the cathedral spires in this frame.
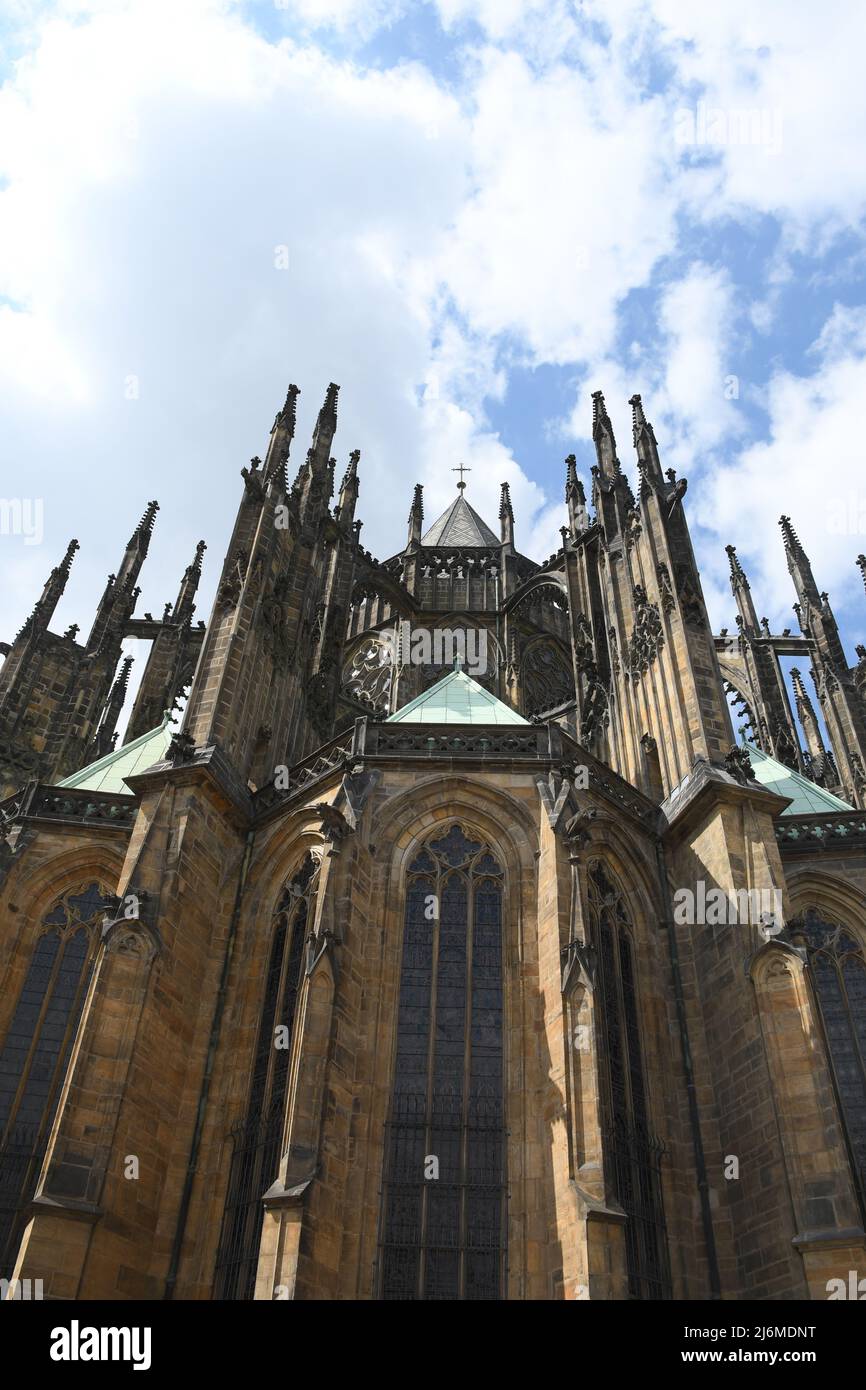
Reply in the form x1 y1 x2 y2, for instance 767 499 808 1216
0 0 866 733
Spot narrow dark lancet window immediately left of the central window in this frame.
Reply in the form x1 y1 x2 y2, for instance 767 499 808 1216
214 855 318 1300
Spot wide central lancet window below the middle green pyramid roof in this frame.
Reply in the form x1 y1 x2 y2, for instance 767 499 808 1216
379 826 506 1300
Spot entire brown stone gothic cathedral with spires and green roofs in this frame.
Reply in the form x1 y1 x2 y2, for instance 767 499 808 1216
0 385 866 1300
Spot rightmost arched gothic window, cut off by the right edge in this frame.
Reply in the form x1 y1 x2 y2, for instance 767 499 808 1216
787 908 866 1207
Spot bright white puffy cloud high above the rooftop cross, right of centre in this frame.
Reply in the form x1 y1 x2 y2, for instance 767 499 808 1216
438 50 677 363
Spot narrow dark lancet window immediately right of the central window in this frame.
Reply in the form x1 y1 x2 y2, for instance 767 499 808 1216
589 863 670 1298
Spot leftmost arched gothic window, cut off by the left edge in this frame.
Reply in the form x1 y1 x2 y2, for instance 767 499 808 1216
0 883 115 1273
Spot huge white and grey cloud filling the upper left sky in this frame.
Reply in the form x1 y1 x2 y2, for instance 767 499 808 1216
0 0 572 658
